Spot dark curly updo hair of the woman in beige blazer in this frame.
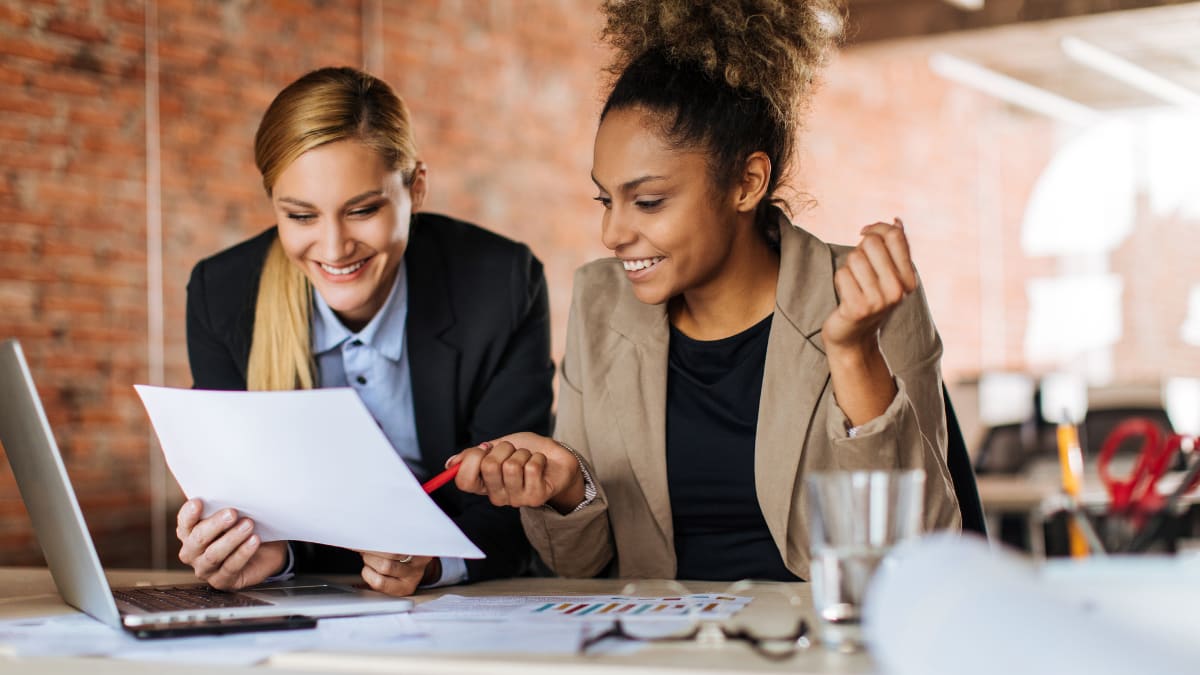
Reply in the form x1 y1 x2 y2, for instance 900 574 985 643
600 0 845 243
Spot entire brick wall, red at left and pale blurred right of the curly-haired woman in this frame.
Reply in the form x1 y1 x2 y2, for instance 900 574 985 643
0 0 1196 566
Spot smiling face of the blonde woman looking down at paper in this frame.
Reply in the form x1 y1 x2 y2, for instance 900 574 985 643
271 141 425 330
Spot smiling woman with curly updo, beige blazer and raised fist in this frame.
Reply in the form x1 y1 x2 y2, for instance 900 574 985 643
451 0 960 580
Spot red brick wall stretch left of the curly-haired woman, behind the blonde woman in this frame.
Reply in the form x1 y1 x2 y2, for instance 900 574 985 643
0 0 601 566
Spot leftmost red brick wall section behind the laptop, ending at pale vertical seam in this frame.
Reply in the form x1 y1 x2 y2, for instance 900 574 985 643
0 1 149 563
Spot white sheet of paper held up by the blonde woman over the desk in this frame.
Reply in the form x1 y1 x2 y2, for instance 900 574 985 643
134 384 484 558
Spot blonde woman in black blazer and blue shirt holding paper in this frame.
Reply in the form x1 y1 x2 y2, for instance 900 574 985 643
176 68 553 596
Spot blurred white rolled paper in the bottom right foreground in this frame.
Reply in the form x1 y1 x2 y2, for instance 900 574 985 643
863 534 1200 675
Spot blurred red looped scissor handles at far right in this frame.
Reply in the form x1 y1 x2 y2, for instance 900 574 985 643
1097 417 1183 515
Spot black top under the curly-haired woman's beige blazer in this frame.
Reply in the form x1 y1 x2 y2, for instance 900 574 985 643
667 316 797 581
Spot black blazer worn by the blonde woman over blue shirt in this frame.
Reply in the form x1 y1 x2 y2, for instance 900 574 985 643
187 214 554 581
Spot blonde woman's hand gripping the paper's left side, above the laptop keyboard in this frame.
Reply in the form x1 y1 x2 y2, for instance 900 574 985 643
175 498 288 591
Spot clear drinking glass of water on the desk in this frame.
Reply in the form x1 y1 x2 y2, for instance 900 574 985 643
805 470 925 652
